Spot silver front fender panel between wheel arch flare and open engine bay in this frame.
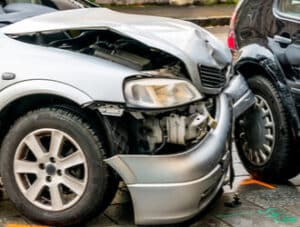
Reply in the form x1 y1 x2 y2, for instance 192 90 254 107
0 33 139 103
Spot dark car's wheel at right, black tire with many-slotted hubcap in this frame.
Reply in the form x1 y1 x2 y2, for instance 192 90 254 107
235 76 298 182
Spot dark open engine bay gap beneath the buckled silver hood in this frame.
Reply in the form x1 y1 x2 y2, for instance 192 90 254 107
14 30 186 76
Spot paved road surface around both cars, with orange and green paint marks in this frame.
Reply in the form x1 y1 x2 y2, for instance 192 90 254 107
0 27 300 227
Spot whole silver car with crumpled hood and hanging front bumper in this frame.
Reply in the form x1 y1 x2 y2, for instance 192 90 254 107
0 4 255 225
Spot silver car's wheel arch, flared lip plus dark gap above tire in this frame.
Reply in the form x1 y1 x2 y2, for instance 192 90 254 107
0 80 119 156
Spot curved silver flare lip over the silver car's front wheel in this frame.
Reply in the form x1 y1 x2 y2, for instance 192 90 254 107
0 80 93 111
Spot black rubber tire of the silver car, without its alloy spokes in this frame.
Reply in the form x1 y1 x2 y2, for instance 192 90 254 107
1 107 123 226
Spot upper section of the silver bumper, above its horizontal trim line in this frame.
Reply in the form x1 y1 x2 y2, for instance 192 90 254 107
106 94 232 184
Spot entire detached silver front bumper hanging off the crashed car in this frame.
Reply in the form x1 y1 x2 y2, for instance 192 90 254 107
106 76 254 224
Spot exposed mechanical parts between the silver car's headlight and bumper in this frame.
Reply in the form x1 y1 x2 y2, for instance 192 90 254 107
98 98 218 155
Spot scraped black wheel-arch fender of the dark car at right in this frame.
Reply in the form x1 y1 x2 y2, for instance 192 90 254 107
234 44 300 142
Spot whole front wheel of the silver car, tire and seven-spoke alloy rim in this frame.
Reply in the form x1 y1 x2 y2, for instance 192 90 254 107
0 107 123 226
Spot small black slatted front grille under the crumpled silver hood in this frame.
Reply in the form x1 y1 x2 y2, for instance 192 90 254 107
199 65 227 88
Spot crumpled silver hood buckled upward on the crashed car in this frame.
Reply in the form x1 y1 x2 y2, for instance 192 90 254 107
1 8 231 89
